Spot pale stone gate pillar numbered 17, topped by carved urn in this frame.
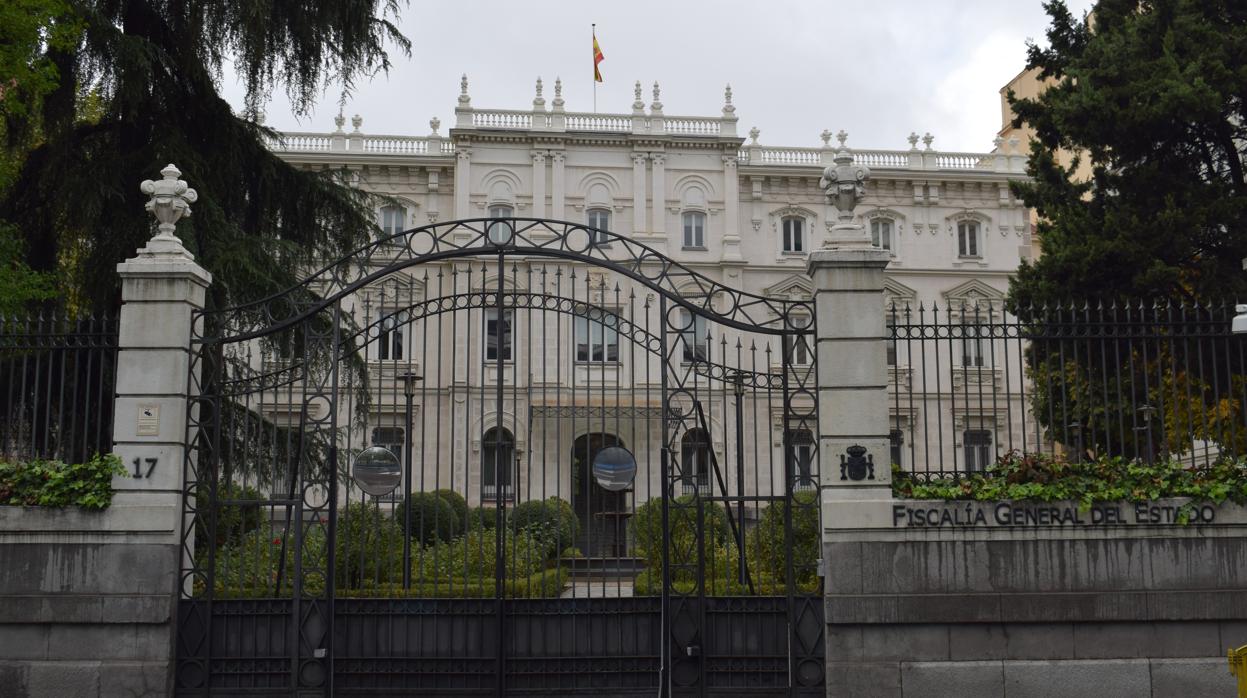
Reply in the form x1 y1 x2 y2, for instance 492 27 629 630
106 165 212 694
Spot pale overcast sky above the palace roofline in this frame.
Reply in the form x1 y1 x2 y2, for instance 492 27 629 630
224 0 1092 151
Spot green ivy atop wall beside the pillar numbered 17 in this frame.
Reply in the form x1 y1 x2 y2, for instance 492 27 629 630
0 454 126 510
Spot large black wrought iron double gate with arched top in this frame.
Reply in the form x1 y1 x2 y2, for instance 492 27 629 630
170 218 824 696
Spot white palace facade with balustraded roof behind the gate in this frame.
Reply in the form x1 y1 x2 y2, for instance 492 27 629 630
265 77 1031 528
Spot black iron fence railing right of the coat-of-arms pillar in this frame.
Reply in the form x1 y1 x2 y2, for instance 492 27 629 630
885 300 1247 477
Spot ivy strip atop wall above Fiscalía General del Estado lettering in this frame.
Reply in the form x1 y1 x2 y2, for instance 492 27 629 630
892 451 1247 518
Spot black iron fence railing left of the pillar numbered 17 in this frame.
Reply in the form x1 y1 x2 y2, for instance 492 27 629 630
0 313 117 462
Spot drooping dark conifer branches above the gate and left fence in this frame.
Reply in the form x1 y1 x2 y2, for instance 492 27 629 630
0 0 409 309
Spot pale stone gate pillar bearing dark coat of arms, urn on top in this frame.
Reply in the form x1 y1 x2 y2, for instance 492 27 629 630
809 138 894 696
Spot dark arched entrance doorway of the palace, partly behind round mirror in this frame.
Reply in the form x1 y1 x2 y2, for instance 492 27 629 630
571 431 632 557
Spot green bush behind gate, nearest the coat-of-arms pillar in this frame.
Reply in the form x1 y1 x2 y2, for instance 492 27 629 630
746 491 823 586
